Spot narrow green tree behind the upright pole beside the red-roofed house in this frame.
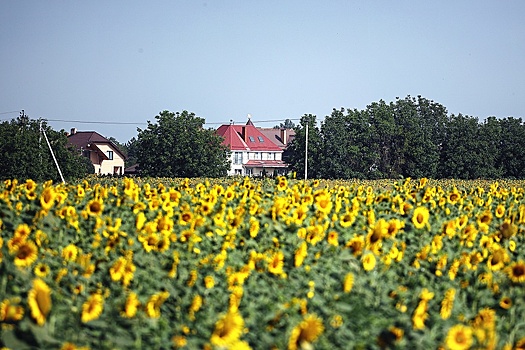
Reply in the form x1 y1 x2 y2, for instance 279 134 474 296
288 114 323 178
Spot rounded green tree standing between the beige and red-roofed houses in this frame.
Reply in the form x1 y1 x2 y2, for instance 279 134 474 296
136 111 230 177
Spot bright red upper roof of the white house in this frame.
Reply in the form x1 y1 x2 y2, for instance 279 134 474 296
217 119 282 152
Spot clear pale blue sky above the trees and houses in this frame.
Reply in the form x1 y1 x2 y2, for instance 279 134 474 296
0 0 525 142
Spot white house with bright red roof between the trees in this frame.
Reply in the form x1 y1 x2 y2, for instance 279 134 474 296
217 119 288 176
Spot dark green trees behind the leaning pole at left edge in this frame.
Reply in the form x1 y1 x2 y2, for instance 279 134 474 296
0 116 94 182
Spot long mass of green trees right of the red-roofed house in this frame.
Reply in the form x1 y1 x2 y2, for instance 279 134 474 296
287 95 525 179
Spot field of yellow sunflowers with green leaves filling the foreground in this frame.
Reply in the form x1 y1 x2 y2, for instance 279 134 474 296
0 177 525 350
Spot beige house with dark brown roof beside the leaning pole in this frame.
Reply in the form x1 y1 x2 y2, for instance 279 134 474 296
67 128 125 175
